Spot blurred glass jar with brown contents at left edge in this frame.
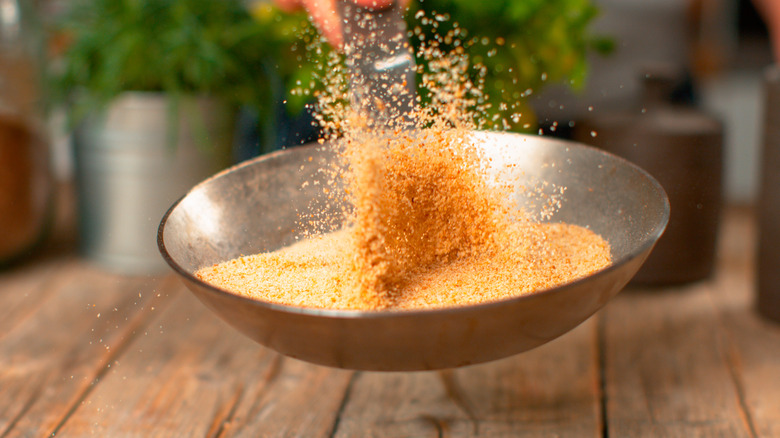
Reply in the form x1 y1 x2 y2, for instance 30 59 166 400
0 0 53 264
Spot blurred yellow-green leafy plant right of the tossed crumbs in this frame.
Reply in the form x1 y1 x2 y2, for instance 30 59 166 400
408 0 612 131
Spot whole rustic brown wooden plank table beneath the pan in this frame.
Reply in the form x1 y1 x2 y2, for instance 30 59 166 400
0 204 780 437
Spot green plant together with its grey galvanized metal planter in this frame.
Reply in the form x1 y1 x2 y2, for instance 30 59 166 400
51 0 300 273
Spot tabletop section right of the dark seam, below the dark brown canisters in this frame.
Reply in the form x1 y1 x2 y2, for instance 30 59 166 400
602 210 780 437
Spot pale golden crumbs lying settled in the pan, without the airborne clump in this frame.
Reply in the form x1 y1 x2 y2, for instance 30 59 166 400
197 224 610 310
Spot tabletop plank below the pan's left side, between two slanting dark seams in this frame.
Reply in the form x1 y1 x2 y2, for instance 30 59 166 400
59 286 350 437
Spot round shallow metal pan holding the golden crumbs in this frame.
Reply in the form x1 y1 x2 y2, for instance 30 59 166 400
158 132 669 371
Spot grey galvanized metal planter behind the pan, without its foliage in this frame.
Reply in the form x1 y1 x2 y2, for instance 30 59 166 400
74 92 235 274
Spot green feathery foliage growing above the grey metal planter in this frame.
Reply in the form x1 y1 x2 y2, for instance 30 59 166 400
50 0 306 128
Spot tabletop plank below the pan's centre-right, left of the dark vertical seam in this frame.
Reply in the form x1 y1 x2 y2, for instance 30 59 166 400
335 320 601 437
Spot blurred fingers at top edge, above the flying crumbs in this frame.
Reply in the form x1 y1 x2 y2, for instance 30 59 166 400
275 0 409 48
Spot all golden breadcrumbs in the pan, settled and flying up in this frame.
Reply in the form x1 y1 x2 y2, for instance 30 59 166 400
196 15 611 310
